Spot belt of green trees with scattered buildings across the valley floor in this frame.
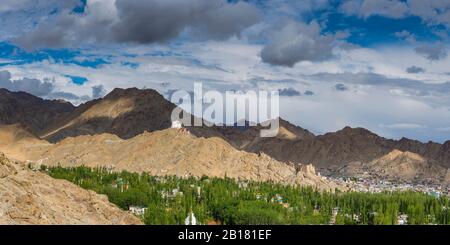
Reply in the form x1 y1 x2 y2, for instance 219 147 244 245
43 167 450 224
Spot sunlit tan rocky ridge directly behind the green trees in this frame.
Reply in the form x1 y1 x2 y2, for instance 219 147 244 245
9 129 337 189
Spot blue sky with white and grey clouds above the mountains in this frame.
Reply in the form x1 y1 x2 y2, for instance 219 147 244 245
0 0 450 142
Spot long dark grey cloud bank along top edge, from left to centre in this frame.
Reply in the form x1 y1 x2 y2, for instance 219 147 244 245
14 0 260 50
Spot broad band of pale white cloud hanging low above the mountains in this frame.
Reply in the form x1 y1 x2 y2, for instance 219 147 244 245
0 39 450 141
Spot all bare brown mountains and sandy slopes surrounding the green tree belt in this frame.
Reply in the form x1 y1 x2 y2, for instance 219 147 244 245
0 88 450 224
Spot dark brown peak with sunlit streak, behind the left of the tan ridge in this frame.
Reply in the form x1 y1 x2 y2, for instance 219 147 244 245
39 88 175 142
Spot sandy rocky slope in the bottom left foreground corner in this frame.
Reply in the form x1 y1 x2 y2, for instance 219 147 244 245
0 153 141 224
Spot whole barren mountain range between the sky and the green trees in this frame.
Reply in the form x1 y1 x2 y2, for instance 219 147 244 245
0 88 450 184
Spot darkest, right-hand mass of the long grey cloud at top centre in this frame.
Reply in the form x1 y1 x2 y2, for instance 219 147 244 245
112 0 259 43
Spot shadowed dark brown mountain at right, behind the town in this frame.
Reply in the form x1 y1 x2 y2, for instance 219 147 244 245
230 127 450 171
